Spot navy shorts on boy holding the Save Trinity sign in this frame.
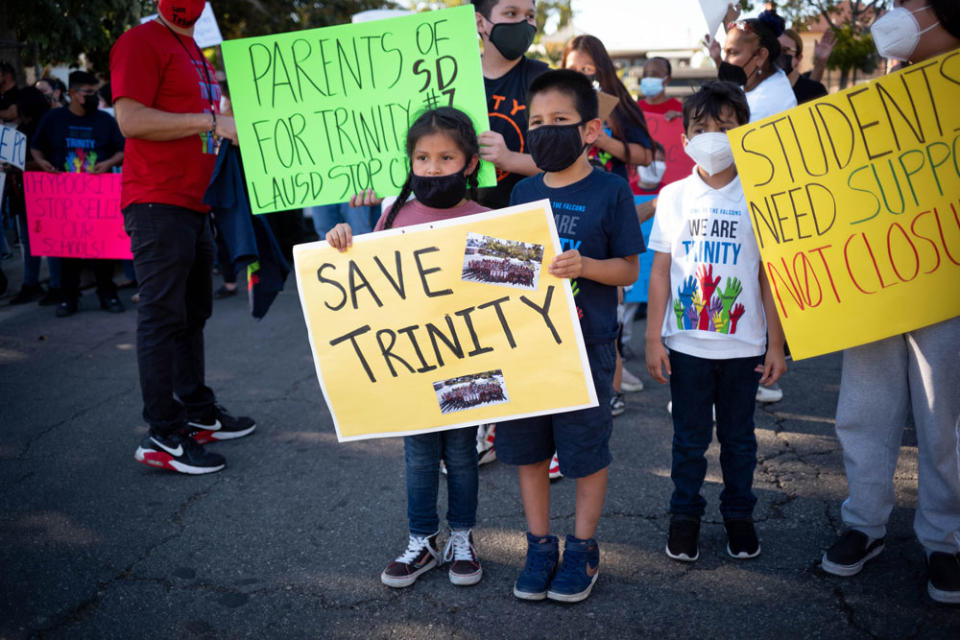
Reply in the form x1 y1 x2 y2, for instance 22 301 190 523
496 341 617 478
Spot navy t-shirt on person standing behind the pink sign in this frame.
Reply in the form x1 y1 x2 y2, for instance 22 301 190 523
31 107 124 173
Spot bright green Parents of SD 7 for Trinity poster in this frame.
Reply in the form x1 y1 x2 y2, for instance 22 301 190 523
222 5 496 213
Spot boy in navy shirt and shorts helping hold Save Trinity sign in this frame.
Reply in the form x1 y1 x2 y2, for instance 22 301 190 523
497 70 644 602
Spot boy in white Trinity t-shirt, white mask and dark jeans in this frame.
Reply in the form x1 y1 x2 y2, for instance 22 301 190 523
647 82 787 562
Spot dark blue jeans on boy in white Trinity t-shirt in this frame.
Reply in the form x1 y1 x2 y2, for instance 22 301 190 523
670 351 763 518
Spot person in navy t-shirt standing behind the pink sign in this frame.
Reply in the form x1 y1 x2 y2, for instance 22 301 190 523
30 71 124 318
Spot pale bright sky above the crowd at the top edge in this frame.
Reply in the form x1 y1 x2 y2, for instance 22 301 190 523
572 0 756 51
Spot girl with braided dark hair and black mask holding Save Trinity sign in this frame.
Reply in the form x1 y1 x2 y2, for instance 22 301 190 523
326 107 487 587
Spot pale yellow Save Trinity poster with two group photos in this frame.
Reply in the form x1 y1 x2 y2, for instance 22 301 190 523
294 200 597 441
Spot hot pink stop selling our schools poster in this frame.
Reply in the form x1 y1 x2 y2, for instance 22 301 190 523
23 171 133 260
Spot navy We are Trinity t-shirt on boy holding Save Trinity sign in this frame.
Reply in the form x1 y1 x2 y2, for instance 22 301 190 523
510 168 646 344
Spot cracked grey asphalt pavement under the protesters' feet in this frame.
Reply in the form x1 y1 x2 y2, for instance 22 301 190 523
0 282 960 639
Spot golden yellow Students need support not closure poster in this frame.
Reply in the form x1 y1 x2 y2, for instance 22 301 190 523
729 50 960 359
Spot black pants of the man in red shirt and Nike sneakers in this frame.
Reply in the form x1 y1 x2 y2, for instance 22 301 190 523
123 204 214 435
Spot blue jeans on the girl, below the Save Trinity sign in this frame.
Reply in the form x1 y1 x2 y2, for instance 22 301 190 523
403 427 479 536
